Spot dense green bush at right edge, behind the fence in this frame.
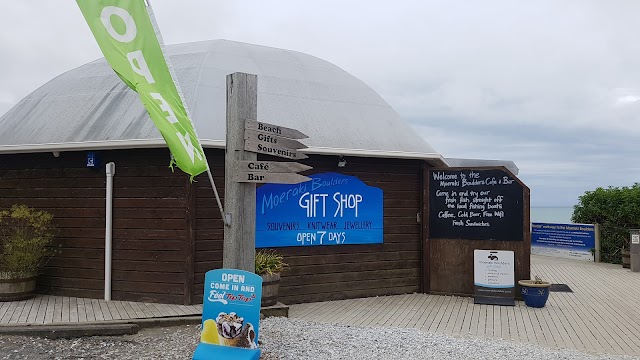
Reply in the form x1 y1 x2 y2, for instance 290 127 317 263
571 183 640 264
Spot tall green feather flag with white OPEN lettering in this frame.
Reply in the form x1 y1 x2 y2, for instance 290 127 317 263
76 0 208 177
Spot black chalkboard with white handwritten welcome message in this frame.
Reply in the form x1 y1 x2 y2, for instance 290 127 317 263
429 169 524 241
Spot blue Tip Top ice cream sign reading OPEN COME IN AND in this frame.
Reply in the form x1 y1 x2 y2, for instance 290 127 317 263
193 269 262 359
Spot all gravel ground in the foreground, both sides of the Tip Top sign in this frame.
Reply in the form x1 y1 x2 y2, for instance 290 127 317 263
0 318 640 360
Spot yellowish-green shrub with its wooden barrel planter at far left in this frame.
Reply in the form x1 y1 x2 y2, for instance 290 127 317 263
0 205 54 301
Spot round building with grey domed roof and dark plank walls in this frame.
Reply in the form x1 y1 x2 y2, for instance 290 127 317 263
0 40 528 304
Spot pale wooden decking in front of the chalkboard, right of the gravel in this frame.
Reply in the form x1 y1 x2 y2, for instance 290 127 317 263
289 256 640 355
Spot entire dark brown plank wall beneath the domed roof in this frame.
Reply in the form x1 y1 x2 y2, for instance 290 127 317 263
0 149 430 304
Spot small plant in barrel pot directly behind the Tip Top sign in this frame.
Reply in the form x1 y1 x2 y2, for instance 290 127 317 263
256 250 288 307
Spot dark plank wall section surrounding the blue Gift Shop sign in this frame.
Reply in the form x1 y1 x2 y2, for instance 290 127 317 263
195 154 423 304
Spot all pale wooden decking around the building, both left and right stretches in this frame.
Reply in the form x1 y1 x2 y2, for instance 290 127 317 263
0 256 640 356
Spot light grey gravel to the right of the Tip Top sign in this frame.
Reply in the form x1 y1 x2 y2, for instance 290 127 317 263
260 318 638 360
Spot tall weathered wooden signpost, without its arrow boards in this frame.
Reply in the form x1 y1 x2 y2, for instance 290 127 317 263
222 73 258 272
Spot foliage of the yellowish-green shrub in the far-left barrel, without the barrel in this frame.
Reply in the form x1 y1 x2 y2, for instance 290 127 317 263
0 205 54 276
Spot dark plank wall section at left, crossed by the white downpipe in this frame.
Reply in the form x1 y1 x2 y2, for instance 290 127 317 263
0 149 191 303
